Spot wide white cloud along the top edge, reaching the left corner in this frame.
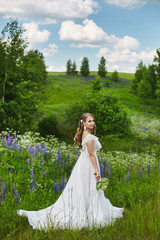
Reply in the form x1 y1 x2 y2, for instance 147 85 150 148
0 0 99 20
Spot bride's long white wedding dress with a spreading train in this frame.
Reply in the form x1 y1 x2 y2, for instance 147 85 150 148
17 134 123 230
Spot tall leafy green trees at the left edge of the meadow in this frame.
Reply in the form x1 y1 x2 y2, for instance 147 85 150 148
0 20 47 132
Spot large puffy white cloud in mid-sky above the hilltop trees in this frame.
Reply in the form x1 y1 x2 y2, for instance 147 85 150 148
59 19 140 50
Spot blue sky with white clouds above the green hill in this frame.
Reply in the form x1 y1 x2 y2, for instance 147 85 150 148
0 0 160 73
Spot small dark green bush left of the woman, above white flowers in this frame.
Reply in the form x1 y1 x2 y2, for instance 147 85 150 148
38 115 60 137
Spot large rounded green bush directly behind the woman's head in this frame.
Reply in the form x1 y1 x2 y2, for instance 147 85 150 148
66 90 129 136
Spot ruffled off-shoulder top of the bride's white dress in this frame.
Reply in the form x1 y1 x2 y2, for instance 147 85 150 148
81 133 102 156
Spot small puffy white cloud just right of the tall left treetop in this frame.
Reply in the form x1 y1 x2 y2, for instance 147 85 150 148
23 22 51 48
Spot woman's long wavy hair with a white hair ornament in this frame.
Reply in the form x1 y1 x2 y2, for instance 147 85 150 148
74 113 96 149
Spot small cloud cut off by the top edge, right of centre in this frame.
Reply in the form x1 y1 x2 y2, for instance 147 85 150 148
105 0 148 8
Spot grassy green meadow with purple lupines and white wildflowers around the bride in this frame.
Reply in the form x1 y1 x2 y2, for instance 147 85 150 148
0 72 160 240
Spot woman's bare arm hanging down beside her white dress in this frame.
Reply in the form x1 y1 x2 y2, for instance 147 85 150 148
87 141 101 181
